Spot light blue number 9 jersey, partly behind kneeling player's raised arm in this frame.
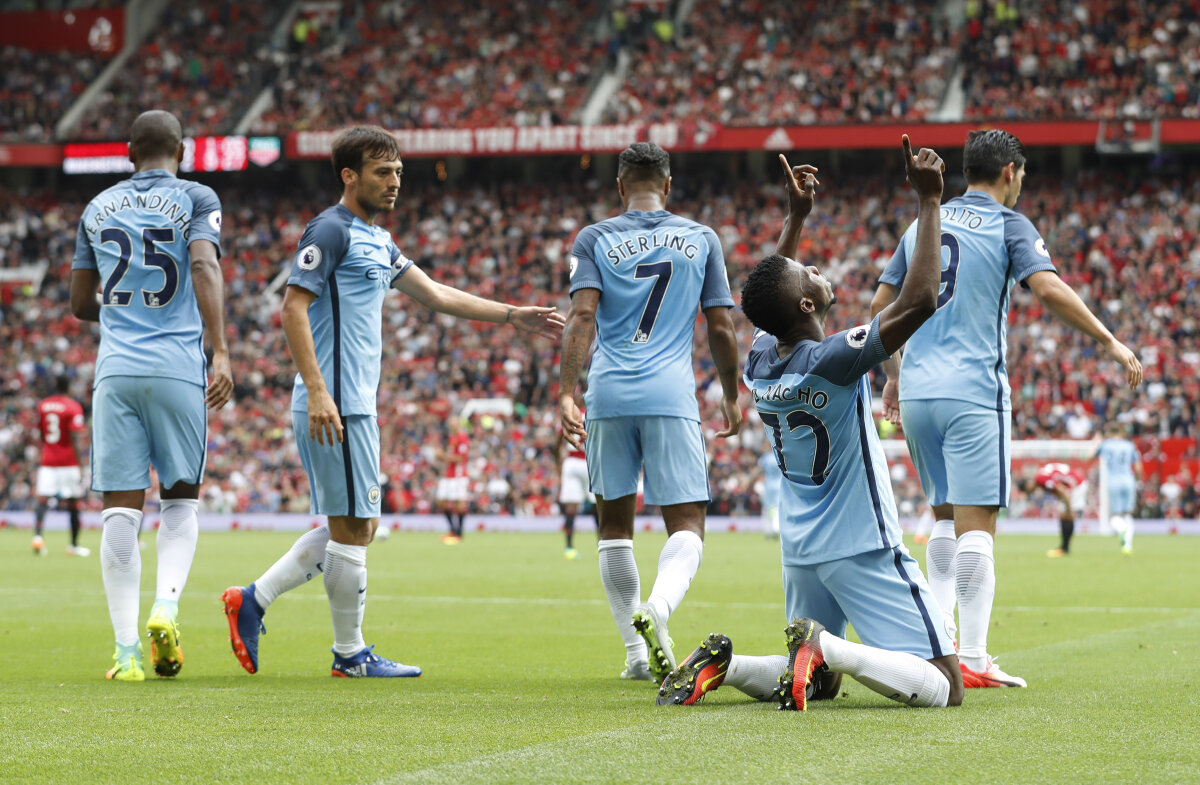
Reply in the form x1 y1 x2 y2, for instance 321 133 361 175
880 191 1055 411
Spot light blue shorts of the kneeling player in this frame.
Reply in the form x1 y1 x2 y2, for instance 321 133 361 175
784 545 954 660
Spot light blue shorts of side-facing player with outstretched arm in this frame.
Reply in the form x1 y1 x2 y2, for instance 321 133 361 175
292 412 380 517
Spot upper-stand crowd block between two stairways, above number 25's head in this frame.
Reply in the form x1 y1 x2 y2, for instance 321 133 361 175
75 0 287 139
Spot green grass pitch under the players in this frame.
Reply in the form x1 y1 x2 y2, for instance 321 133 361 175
0 529 1200 785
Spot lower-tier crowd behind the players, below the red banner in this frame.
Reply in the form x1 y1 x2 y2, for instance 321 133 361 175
0 173 1200 517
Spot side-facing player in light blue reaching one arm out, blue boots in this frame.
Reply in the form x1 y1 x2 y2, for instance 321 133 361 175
221 126 563 677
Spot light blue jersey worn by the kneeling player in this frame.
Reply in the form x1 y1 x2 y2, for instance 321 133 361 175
745 318 902 567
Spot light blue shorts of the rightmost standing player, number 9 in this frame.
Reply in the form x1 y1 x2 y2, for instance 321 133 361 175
900 399 1013 507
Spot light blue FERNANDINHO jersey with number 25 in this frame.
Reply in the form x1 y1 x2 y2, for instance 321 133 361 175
71 169 221 386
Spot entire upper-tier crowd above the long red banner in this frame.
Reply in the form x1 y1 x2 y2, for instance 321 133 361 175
7 0 1200 140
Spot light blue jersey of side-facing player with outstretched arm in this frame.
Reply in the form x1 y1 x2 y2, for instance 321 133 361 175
288 204 413 417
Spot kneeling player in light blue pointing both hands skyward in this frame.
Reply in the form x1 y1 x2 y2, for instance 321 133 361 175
658 136 962 711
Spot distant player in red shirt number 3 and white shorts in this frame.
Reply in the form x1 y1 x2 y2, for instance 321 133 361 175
34 376 91 556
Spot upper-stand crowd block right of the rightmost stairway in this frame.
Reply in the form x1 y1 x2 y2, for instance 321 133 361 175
962 0 1200 120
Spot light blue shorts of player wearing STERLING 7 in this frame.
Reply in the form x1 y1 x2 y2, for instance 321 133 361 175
583 417 709 507
